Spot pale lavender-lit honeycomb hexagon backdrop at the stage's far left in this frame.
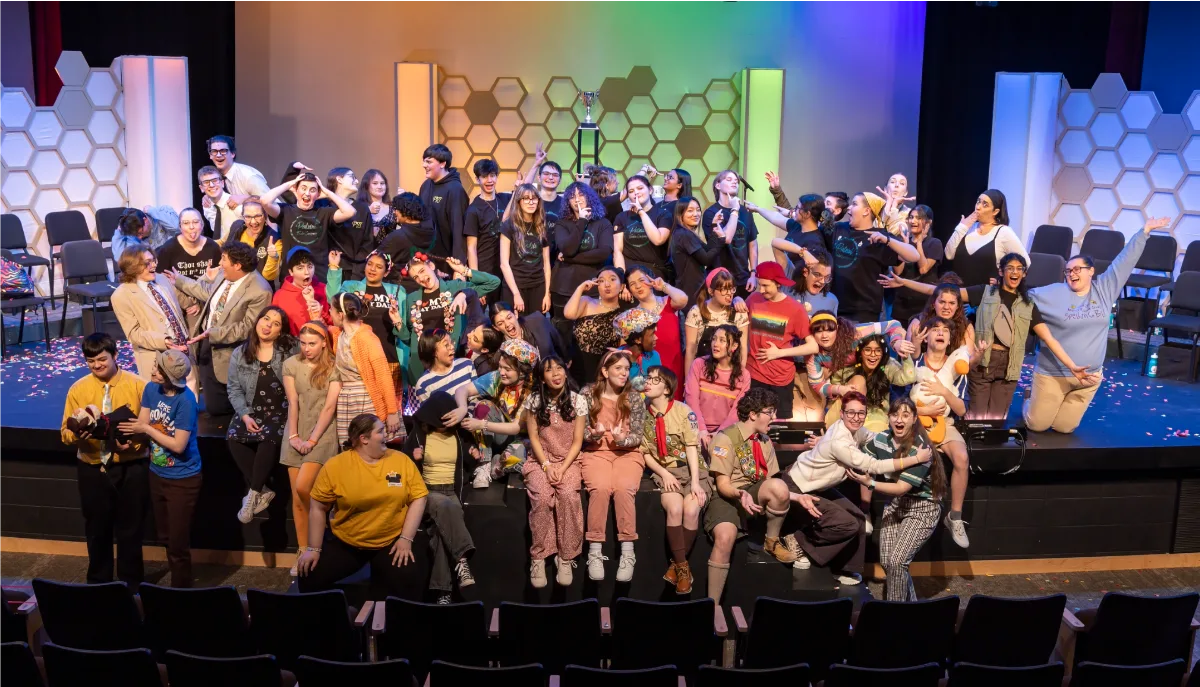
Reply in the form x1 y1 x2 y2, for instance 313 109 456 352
0 50 128 289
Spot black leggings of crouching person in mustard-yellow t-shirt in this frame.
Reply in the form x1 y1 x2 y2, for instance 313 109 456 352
298 531 430 601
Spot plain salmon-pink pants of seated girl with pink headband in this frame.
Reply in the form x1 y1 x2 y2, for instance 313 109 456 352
580 449 646 542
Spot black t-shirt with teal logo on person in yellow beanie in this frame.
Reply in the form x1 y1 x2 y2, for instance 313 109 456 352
828 222 900 322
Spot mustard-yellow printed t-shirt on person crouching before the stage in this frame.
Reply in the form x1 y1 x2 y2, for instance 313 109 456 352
312 449 430 549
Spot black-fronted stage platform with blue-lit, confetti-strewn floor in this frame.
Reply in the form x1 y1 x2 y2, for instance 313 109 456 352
7 337 1200 604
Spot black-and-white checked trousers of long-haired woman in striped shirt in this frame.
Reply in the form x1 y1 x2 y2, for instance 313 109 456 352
880 495 942 601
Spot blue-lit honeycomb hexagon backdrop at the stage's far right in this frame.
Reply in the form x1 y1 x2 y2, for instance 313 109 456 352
1050 73 1200 259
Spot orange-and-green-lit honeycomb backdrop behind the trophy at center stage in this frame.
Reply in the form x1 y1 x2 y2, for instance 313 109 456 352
438 66 742 203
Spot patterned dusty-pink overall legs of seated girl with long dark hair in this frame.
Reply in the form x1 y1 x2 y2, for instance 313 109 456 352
522 459 583 561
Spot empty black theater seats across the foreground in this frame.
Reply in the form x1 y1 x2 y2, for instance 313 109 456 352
0 580 1200 687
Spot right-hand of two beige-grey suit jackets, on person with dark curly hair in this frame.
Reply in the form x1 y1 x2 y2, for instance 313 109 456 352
175 270 271 384
